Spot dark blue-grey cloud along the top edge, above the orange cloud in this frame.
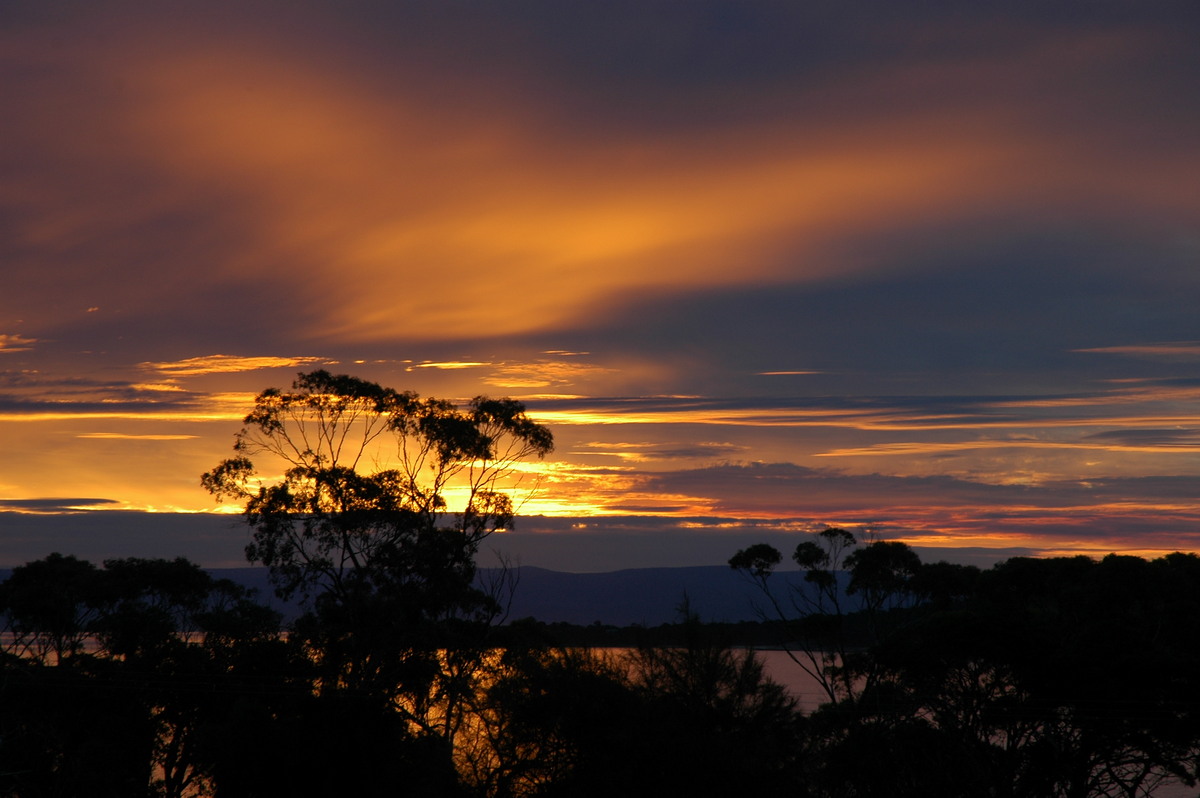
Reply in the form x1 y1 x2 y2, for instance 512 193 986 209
333 0 1200 131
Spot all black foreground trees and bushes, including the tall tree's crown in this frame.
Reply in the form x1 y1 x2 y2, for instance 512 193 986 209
0 372 1200 798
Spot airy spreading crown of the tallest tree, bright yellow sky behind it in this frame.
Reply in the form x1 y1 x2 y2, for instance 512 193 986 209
202 371 553 600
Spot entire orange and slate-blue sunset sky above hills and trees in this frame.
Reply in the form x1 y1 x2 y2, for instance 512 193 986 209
0 0 1200 570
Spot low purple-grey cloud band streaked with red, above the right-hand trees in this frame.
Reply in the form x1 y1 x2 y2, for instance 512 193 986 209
628 463 1200 548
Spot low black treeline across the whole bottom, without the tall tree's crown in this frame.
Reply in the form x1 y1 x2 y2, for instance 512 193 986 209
0 530 1200 798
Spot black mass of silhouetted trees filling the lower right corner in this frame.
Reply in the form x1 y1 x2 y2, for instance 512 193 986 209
731 529 1200 798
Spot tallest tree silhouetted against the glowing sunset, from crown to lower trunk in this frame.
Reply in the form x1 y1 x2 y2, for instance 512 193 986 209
202 371 553 768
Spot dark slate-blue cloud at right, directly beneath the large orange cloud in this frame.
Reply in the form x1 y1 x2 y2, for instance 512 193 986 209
540 222 1200 394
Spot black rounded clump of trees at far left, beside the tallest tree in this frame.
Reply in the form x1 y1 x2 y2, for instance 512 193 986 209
0 554 283 798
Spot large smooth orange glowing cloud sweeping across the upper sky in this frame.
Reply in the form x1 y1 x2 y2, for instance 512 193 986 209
4 21 1176 341
